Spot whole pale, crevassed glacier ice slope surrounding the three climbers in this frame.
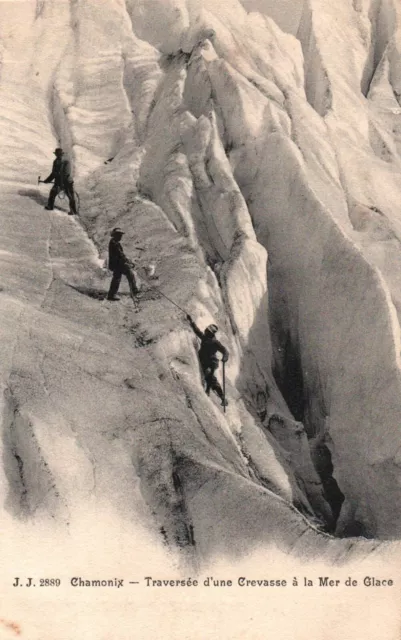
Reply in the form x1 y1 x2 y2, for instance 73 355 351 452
0 0 401 566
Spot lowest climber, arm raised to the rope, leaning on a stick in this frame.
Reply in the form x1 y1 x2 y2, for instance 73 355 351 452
187 315 229 406
